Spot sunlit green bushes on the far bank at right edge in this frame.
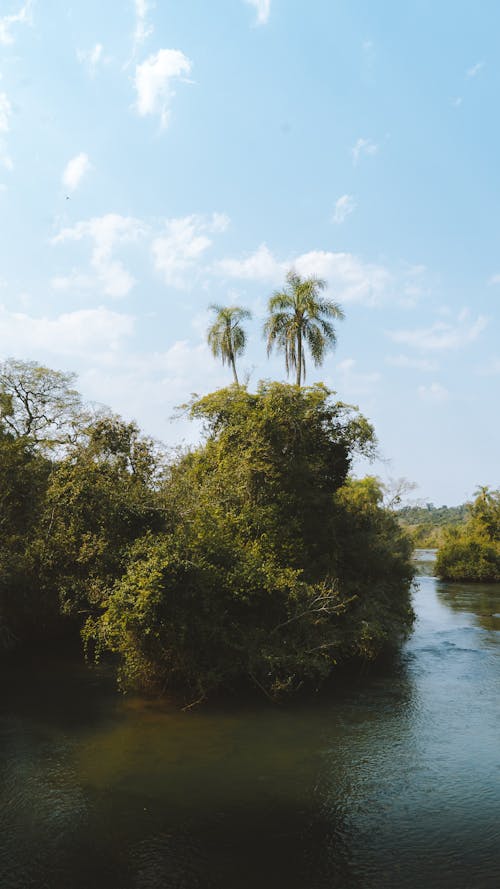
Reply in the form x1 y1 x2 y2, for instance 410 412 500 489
436 487 500 583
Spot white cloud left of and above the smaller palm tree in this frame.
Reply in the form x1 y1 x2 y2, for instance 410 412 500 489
151 213 229 288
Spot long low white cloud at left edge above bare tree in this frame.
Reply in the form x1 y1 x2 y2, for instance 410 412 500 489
0 306 134 357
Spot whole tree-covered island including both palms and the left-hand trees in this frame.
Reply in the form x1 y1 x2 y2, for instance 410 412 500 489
0 272 413 702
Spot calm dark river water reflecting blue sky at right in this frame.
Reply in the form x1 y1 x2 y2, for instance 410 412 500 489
0 552 500 889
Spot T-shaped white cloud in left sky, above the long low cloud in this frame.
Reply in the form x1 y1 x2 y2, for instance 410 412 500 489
52 213 147 298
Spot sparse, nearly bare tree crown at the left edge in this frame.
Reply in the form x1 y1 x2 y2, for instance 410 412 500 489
0 358 88 450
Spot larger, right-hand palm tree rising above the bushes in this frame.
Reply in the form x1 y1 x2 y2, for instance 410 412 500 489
264 269 344 386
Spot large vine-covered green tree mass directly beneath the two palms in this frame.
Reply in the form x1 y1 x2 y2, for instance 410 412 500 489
85 383 412 701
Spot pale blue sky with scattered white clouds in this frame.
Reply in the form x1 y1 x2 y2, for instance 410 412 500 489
0 0 500 505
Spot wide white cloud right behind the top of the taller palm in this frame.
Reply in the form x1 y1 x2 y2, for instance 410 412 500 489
214 244 392 305
